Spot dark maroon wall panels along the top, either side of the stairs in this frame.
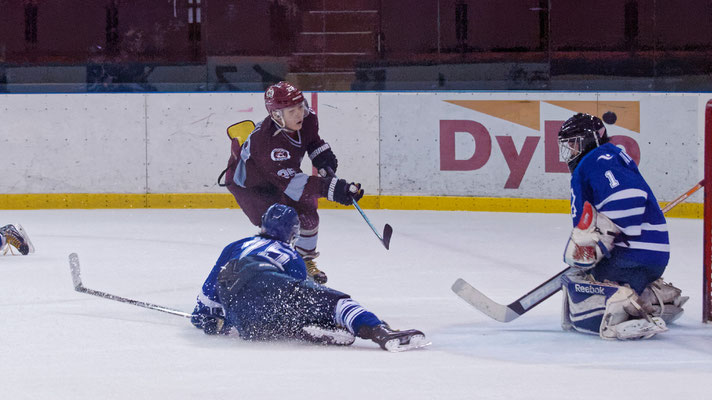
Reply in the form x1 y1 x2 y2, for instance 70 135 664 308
0 0 712 64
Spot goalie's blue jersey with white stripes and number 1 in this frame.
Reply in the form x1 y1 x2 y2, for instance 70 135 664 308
571 143 670 267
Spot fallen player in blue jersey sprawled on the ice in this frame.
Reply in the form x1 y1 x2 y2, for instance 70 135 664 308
191 204 429 351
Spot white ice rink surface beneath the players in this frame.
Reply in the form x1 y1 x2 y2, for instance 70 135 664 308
0 209 712 400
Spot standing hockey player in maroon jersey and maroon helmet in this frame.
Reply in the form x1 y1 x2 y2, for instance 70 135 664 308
226 82 363 283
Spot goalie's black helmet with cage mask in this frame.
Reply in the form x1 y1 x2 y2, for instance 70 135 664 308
559 113 608 172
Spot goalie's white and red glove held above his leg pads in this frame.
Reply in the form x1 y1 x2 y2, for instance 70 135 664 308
564 202 620 270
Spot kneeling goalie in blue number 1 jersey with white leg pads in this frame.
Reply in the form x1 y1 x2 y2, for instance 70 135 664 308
558 113 688 339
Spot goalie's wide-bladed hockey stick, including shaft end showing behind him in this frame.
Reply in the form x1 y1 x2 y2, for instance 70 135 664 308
451 180 704 322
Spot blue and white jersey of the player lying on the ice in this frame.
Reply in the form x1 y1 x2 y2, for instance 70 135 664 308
194 236 307 315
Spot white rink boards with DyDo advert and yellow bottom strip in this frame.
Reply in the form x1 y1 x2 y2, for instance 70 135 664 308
0 92 710 216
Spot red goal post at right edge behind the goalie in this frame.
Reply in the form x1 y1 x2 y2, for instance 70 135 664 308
702 100 712 322
